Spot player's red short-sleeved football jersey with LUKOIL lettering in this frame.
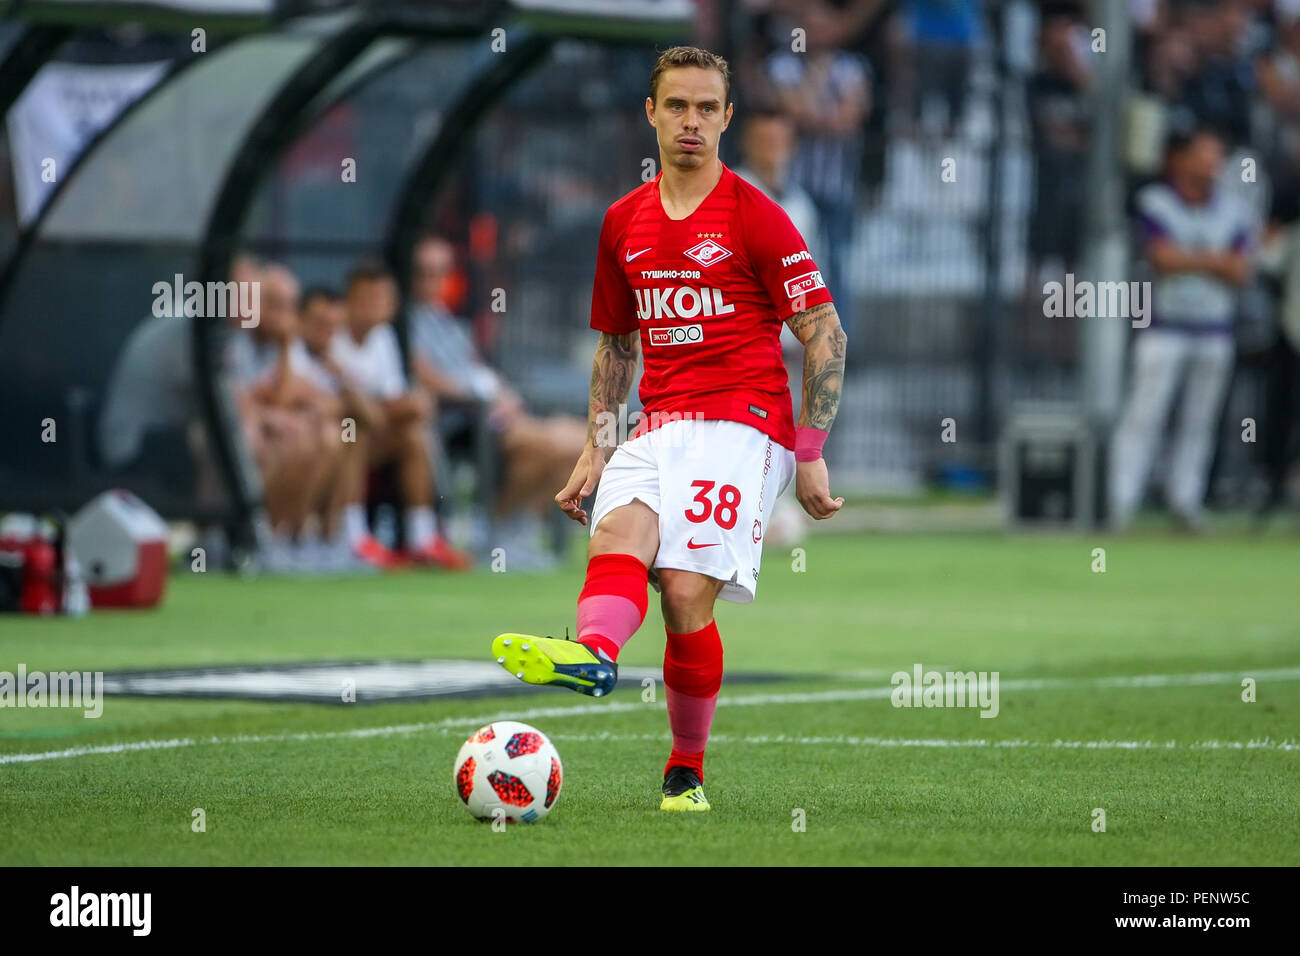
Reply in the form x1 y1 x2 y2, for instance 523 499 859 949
592 164 831 449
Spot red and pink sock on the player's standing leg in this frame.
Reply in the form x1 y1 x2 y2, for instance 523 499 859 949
663 620 723 782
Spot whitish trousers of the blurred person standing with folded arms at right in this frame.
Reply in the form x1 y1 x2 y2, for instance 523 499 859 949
1110 328 1234 528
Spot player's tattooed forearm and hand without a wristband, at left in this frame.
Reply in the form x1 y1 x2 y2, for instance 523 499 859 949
555 332 641 524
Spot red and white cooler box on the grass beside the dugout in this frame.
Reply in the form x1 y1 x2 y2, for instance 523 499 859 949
68 489 166 607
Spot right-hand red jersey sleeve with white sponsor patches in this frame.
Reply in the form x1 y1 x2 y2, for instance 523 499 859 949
745 190 831 321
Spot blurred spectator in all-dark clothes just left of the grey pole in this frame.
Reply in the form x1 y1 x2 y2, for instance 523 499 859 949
1027 12 1091 277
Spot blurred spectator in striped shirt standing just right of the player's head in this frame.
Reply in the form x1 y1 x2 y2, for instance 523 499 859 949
767 0 871 319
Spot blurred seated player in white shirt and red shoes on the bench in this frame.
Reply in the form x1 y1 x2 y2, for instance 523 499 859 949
332 263 471 570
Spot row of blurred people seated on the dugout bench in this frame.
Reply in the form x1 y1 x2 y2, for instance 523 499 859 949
204 247 586 571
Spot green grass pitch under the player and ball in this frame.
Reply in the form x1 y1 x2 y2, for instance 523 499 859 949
0 533 1300 865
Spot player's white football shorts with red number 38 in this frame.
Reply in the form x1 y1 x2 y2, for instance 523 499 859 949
590 419 794 604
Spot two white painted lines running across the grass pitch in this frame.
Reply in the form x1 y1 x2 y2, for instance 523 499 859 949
0 667 1300 765
